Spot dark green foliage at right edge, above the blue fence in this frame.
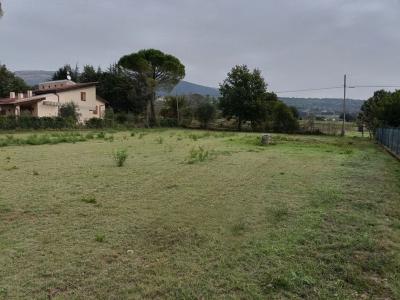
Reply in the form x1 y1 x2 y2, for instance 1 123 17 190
358 90 400 134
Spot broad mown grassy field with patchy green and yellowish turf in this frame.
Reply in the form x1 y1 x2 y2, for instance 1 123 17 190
0 130 400 299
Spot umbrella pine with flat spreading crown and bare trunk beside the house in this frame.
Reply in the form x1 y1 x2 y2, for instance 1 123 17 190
118 49 185 126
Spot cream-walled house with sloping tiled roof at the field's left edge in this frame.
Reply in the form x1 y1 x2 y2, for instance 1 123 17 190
0 80 107 122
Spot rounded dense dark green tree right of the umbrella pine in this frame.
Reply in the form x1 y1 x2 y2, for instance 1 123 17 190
219 65 277 131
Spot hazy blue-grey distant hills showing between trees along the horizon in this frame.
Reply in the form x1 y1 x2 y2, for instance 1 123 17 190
15 71 364 115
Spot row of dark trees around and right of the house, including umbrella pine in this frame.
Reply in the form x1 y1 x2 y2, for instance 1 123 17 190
0 49 299 132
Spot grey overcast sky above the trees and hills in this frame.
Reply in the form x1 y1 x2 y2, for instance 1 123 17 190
0 0 400 98
